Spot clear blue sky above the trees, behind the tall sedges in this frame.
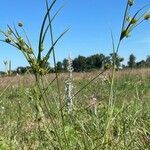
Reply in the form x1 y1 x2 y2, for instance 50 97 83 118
0 0 150 70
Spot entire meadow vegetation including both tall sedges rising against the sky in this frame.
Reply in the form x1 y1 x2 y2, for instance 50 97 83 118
0 0 150 150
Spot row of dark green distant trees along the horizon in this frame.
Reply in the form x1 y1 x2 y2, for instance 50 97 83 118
0 53 150 74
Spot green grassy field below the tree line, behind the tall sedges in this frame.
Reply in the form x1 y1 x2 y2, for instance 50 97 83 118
0 69 150 150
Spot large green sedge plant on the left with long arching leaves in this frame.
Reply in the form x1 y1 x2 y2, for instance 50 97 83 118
0 0 68 147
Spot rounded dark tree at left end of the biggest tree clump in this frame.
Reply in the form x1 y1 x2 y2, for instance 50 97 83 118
73 55 87 72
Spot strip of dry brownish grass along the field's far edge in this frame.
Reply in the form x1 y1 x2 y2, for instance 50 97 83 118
0 68 150 88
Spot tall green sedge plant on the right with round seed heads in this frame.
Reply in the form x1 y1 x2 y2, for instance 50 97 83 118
103 0 150 148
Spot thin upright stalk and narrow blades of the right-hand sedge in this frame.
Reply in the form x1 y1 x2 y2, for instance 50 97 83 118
103 0 147 148
